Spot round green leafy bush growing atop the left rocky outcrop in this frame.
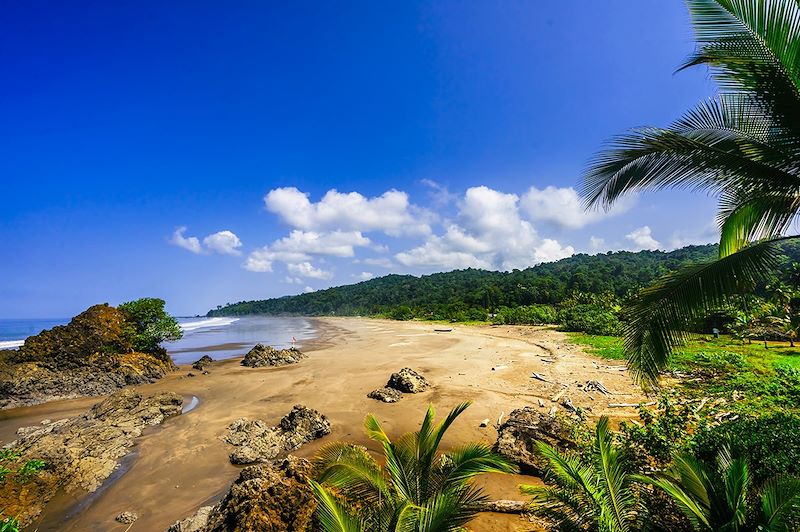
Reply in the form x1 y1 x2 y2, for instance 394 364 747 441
117 297 183 353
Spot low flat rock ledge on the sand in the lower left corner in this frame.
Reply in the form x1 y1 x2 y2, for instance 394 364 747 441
0 389 183 524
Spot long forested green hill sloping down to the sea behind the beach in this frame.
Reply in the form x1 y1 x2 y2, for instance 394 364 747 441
208 245 736 318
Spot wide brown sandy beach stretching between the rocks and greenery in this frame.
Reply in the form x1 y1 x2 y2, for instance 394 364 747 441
0 318 643 532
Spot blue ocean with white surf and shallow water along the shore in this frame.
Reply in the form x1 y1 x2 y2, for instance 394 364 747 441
0 316 317 364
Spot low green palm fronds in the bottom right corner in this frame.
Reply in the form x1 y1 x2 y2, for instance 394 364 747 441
641 448 800 532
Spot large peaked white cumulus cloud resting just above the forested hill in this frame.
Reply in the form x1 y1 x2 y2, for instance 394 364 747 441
395 186 575 270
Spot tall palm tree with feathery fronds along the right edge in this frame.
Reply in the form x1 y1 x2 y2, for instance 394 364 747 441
582 0 800 386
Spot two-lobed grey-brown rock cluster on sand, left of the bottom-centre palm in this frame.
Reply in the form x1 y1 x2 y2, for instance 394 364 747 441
222 405 331 464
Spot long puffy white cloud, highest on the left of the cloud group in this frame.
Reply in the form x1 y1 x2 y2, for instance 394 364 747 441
264 187 430 236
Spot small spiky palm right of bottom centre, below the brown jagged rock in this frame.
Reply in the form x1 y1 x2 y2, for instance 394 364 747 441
520 416 645 532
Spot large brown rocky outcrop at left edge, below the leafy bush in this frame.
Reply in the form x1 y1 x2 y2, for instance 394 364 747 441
0 305 175 408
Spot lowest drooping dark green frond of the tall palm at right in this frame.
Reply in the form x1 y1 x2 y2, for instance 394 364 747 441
623 239 785 386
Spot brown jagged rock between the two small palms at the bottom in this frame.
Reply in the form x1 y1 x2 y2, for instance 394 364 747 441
495 406 575 475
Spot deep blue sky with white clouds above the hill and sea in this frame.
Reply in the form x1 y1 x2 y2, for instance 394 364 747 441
0 0 715 317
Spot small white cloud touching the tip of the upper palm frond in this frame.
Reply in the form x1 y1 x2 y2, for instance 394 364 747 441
520 186 636 229
